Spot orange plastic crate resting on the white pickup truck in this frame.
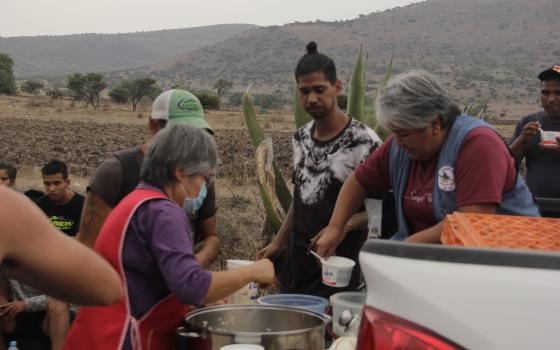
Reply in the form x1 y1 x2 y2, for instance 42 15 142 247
441 212 560 251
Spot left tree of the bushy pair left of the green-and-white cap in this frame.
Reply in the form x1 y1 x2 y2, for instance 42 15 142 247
66 73 107 109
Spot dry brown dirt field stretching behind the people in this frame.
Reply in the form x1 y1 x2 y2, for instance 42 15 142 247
0 96 524 267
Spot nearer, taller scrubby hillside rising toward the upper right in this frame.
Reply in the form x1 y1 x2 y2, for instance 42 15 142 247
130 0 560 108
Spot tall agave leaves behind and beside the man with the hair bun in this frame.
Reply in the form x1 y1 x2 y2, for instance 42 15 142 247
243 46 393 232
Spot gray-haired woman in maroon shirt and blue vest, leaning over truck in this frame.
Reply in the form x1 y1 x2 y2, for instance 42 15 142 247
316 70 538 256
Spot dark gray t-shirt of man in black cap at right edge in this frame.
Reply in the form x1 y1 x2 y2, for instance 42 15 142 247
510 111 560 198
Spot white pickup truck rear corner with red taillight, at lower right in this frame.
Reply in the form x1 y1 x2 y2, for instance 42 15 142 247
357 240 560 350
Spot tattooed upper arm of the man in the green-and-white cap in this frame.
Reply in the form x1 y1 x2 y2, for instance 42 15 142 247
77 190 112 248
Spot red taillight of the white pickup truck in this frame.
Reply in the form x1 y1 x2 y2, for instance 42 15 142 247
357 305 463 350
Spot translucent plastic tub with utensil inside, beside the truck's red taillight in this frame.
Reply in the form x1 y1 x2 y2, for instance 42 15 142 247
330 292 366 337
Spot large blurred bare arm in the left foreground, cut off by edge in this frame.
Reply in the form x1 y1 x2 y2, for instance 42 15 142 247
0 188 122 305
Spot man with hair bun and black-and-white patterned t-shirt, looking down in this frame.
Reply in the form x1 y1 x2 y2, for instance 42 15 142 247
257 42 381 297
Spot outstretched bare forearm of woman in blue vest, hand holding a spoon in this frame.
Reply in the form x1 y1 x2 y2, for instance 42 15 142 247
310 173 367 257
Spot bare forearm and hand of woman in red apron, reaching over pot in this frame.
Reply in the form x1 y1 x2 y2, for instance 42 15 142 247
206 259 276 303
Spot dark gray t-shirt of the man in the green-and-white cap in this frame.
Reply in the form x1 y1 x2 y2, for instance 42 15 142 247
87 146 217 227
